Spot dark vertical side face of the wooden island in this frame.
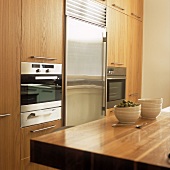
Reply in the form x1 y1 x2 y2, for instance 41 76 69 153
31 141 135 170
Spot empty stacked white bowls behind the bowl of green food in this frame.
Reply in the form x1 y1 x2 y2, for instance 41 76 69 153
138 98 163 119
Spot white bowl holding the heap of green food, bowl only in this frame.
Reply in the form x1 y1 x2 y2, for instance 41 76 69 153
114 105 141 123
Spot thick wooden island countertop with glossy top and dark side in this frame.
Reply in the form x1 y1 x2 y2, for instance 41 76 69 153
31 107 170 170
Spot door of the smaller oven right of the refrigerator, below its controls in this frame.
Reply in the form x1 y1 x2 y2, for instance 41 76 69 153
107 76 126 108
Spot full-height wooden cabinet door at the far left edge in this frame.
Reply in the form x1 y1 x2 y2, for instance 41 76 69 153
0 0 21 170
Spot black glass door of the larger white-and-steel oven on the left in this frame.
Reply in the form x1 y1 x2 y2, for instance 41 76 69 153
21 75 62 105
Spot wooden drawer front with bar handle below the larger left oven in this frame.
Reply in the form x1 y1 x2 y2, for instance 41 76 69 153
21 120 62 159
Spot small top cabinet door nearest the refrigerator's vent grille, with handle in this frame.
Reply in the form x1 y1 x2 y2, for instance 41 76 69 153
107 0 129 14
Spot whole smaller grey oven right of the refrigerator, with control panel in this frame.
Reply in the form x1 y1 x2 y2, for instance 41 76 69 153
107 67 126 108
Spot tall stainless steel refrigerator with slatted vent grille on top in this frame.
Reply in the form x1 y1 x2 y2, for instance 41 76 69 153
65 0 106 126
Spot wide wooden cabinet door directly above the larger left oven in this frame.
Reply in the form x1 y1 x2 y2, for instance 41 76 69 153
21 0 64 63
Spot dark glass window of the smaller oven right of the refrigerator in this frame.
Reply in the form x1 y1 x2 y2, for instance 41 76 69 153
107 79 125 102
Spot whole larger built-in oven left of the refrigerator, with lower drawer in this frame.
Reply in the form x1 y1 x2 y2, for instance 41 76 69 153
21 62 62 127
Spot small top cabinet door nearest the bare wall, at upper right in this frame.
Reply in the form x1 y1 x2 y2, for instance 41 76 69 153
129 0 143 21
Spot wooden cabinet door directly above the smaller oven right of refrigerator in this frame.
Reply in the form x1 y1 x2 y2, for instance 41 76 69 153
107 7 127 67
